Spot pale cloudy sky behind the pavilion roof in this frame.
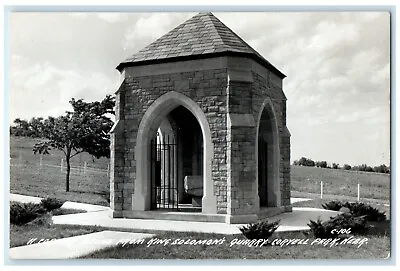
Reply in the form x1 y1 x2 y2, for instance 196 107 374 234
8 12 390 166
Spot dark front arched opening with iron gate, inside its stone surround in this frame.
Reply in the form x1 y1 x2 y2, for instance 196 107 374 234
150 106 204 211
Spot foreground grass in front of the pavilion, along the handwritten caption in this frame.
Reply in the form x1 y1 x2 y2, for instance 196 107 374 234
10 211 390 259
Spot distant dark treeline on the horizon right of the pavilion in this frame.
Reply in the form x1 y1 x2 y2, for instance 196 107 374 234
293 157 390 173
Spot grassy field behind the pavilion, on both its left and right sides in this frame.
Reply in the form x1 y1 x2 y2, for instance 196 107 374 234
10 137 390 206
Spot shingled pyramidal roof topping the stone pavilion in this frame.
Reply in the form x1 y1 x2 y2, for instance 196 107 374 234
117 12 286 78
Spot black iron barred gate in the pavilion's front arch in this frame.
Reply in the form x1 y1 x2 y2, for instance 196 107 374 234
150 132 179 210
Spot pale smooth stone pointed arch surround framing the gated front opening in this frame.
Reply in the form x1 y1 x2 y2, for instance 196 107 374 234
132 91 217 214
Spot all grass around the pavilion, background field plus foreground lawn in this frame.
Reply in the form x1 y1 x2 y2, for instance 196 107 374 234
10 137 390 259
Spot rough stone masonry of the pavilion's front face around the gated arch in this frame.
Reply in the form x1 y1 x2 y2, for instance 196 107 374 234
113 69 227 213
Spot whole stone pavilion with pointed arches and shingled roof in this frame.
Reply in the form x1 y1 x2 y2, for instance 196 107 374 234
110 13 291 223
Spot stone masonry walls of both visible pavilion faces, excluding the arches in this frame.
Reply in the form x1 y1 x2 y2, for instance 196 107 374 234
110 58 290 219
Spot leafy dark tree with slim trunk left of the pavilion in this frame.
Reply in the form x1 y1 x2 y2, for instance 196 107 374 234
33 95 115 192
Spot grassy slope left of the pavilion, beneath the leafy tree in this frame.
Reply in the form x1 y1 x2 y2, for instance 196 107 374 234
10 137 109 206
